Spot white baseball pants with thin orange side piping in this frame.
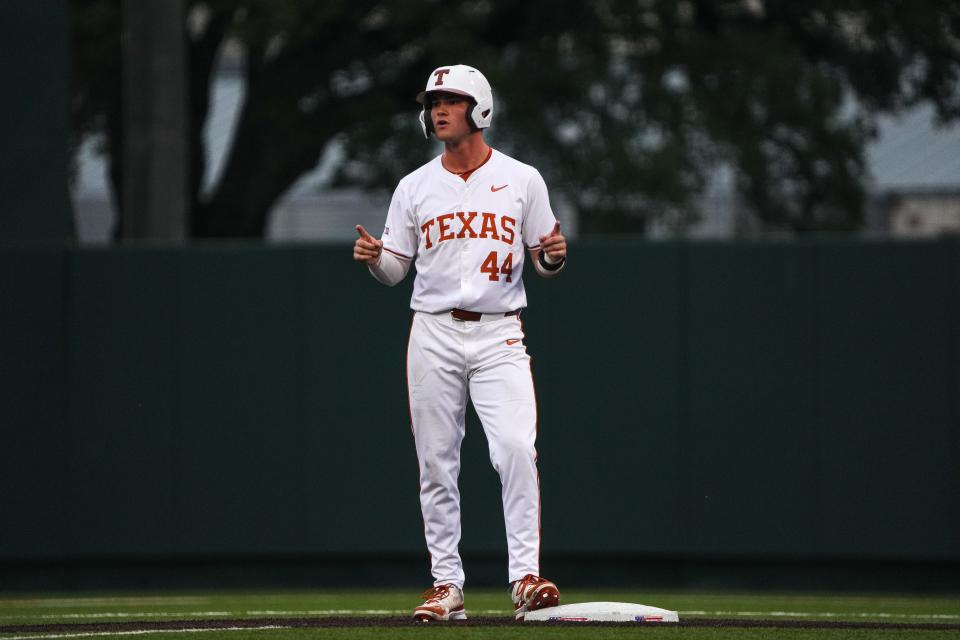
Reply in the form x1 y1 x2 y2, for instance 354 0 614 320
407 312 540 589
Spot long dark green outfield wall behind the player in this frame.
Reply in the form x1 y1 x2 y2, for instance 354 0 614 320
0 241 960 564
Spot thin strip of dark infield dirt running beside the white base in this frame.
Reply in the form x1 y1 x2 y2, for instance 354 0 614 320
0 616 960 633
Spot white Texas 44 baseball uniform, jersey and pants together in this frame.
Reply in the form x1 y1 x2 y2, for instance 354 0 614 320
370 151 556 588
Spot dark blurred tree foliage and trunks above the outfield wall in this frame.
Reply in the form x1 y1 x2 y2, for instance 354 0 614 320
72 0 960 237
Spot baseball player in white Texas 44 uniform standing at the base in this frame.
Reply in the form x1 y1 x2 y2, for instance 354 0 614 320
353 65 567 621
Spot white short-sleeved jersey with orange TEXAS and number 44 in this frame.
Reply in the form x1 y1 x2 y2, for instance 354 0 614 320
382 150 556 313
